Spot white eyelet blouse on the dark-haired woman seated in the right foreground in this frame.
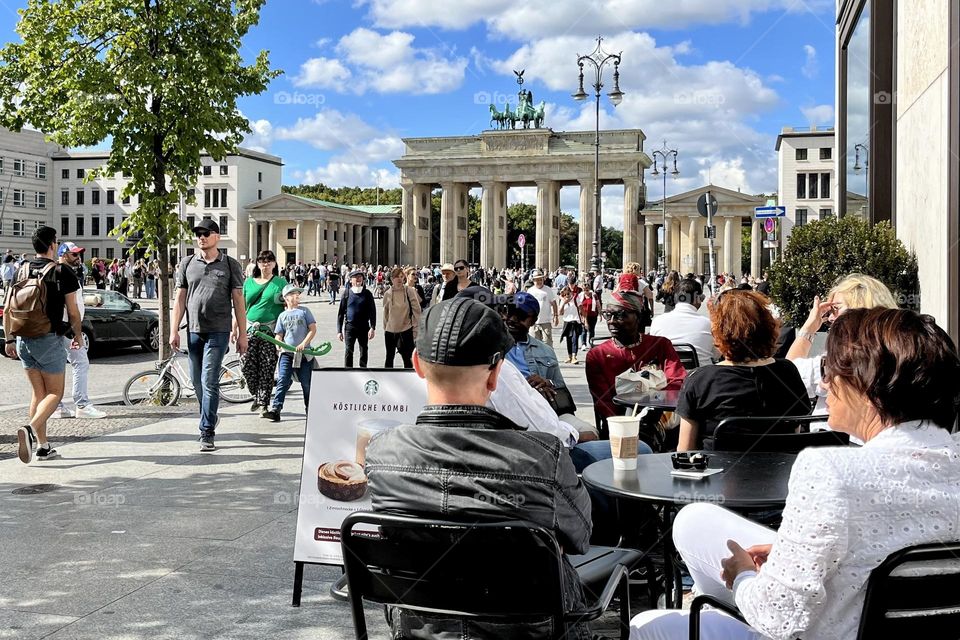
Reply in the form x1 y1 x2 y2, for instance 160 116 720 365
734 422 960 640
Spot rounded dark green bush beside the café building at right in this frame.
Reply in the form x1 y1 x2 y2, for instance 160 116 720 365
770 216 920 324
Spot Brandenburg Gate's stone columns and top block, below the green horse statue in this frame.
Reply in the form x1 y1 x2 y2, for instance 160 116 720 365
394 128 656 273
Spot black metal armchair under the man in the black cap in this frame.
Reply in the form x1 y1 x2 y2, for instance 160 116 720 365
341 512 643 640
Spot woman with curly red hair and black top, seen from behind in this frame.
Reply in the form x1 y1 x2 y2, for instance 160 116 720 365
677 290 810 451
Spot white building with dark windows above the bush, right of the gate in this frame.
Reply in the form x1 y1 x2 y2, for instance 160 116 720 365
772 127 837 247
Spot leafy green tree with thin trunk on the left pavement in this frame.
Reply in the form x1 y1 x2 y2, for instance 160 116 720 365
0 0 279 355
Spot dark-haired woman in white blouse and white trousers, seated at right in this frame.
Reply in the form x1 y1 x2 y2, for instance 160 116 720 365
631 308 960 640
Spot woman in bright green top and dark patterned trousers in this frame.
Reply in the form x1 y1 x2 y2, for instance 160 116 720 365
241 251 287 413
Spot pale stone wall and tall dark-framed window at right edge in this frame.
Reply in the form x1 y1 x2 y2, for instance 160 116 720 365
837 0 960 341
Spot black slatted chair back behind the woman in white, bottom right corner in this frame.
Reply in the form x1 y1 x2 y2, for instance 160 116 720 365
857 542 960 640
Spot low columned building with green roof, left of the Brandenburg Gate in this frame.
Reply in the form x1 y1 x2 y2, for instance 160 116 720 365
246 193 401 265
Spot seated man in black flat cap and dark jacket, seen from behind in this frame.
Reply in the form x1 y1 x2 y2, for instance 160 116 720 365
366 298 592 639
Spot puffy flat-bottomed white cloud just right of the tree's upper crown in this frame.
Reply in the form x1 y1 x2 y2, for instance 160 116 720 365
293 27 468 94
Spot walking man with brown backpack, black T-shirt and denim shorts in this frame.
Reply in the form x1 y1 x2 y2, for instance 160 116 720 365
3 226 83 464
